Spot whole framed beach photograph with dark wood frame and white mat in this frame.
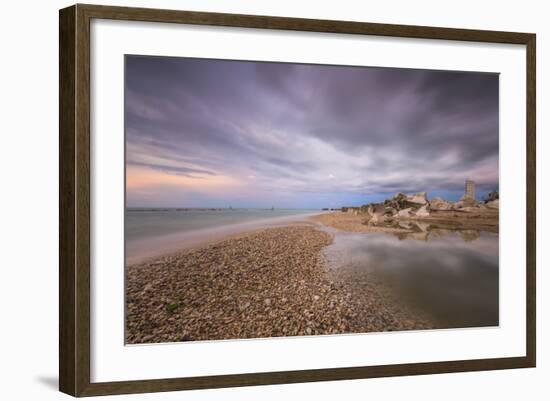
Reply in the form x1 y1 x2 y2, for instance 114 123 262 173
59 5 536 396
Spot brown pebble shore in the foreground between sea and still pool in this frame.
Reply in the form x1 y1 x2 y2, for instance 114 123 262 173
126 226 431 344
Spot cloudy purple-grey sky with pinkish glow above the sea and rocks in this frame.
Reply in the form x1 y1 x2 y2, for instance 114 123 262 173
125 56 499 209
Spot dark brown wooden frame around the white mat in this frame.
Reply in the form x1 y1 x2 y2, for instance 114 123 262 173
59 4 536 396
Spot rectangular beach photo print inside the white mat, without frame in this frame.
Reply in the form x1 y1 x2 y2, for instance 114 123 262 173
125 55 499 344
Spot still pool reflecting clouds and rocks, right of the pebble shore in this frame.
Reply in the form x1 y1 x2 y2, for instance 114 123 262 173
325 228 499 328
